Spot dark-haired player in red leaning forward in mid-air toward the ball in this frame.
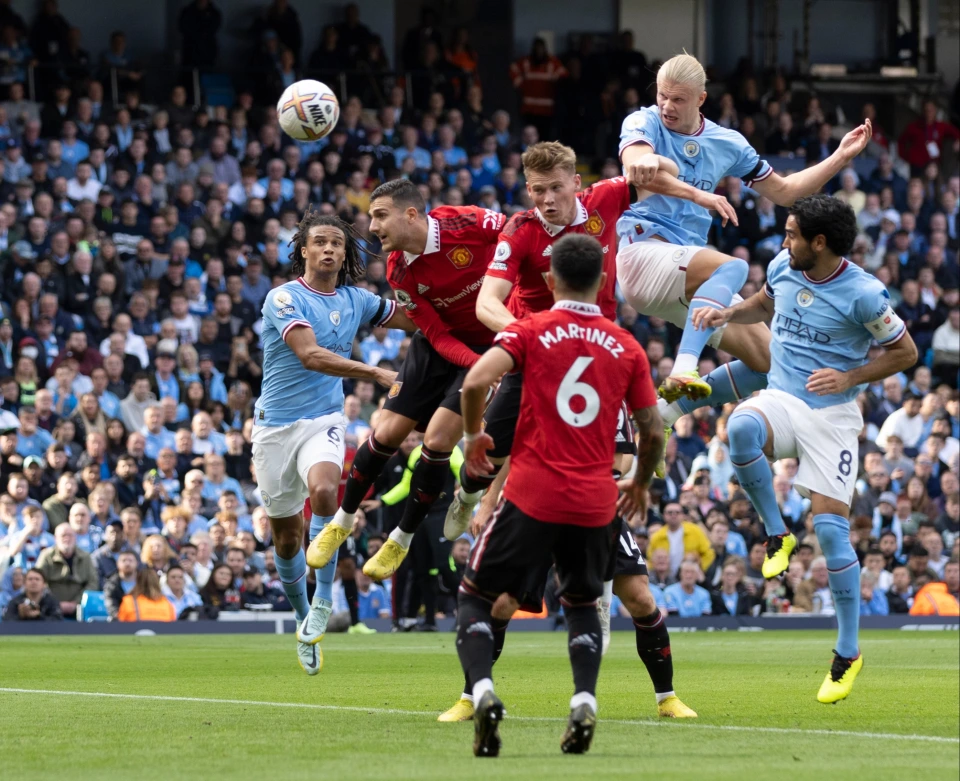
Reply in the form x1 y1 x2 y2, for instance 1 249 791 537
307 179 504 580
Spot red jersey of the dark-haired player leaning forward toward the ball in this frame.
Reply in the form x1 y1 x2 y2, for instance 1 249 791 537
387 206 505 366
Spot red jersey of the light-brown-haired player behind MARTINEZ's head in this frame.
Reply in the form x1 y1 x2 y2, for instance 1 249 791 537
487 176 631 320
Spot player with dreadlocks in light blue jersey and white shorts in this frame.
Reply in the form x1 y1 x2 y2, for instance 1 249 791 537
253 208 416 675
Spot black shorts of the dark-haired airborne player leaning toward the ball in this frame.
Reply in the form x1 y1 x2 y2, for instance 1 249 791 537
383 331 483 428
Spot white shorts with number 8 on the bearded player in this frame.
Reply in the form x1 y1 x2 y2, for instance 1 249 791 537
740 390 863 504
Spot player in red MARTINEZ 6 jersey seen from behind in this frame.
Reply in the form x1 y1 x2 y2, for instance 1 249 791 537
457 235 660 756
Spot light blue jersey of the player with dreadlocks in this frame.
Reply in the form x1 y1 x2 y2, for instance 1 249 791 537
254 278 396 426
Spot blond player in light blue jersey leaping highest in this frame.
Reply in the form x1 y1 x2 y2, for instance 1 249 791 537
617 54 872 578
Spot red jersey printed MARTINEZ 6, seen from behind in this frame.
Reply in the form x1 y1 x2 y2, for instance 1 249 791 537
496 301 657 526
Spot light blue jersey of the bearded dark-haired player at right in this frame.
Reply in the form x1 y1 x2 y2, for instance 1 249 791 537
764 250 907 409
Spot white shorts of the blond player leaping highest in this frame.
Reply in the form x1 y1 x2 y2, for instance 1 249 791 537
617 240 743 347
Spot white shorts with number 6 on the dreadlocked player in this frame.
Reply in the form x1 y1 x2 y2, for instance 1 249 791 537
252 412 347 518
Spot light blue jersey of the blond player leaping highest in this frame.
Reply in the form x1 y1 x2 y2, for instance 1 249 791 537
617 106 773 247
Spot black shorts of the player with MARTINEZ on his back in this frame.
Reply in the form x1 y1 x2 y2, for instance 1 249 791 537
461 499 612 613
